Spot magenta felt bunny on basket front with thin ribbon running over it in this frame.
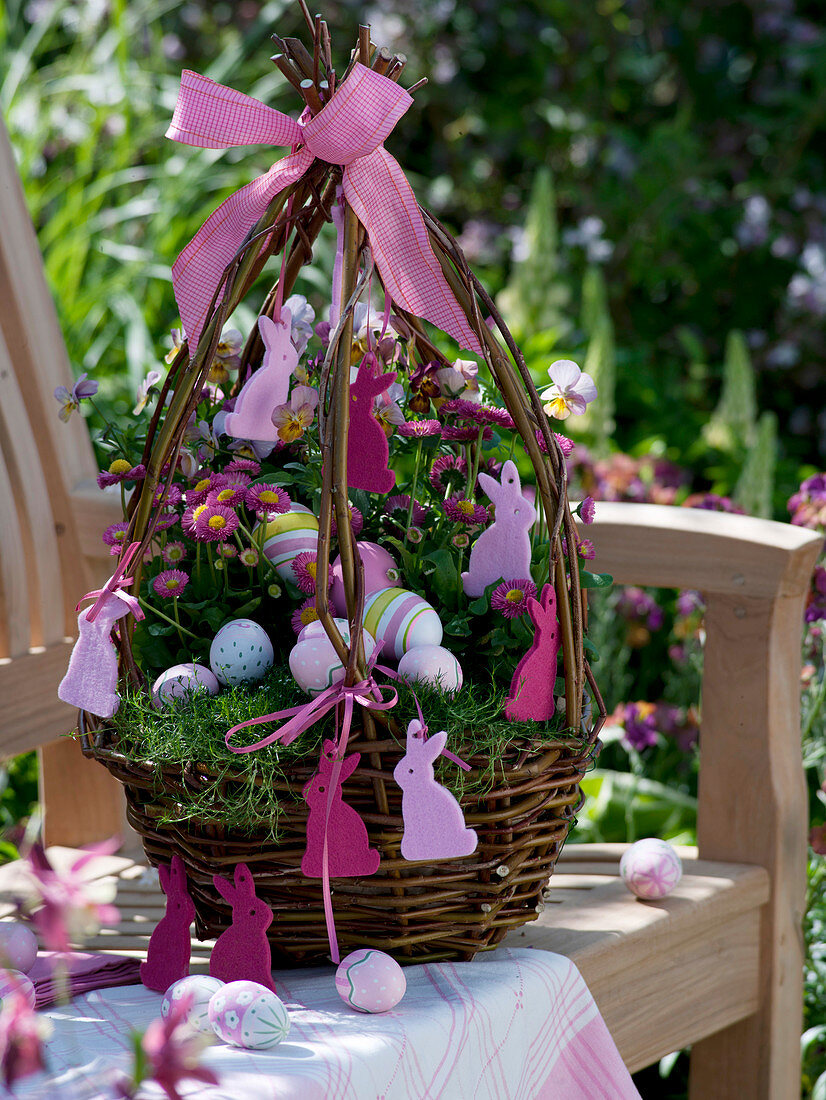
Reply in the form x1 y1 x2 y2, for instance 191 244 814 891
301 741 381 879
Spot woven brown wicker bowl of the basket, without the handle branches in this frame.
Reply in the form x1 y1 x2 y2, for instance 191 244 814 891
81 719 594 967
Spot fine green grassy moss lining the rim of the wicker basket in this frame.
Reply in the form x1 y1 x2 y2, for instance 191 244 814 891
112 668 570 839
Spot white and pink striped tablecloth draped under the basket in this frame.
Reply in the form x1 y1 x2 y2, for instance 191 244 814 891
15 948 639 1100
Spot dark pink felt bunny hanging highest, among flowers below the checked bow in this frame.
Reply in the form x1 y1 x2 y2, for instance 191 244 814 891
348 354 396 493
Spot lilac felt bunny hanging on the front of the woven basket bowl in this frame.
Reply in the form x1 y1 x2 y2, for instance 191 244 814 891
393 718 478 859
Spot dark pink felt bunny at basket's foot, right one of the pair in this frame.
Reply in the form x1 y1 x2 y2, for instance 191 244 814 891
209 864 275 992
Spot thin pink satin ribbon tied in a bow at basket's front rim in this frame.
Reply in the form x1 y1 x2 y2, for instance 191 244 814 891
224 641 471 963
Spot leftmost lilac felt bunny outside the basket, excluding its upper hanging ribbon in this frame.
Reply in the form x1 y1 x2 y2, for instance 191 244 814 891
57 593 132 718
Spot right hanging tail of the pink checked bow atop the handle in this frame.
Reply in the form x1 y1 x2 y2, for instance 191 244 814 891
343 146 483 355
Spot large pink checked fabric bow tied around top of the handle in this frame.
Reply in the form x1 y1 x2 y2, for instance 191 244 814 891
166 63 483 355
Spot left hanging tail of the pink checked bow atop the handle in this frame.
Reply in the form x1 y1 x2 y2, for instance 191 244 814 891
172 149 312 356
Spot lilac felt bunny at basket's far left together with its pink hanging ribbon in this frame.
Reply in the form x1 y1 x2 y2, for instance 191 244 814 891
57 542 144 718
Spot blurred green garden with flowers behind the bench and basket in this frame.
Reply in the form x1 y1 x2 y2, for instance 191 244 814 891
0 0 826 1100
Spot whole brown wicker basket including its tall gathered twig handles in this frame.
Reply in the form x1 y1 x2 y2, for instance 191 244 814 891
81 20 605 965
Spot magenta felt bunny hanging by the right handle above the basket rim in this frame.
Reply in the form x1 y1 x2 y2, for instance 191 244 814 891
505 584 560 722
